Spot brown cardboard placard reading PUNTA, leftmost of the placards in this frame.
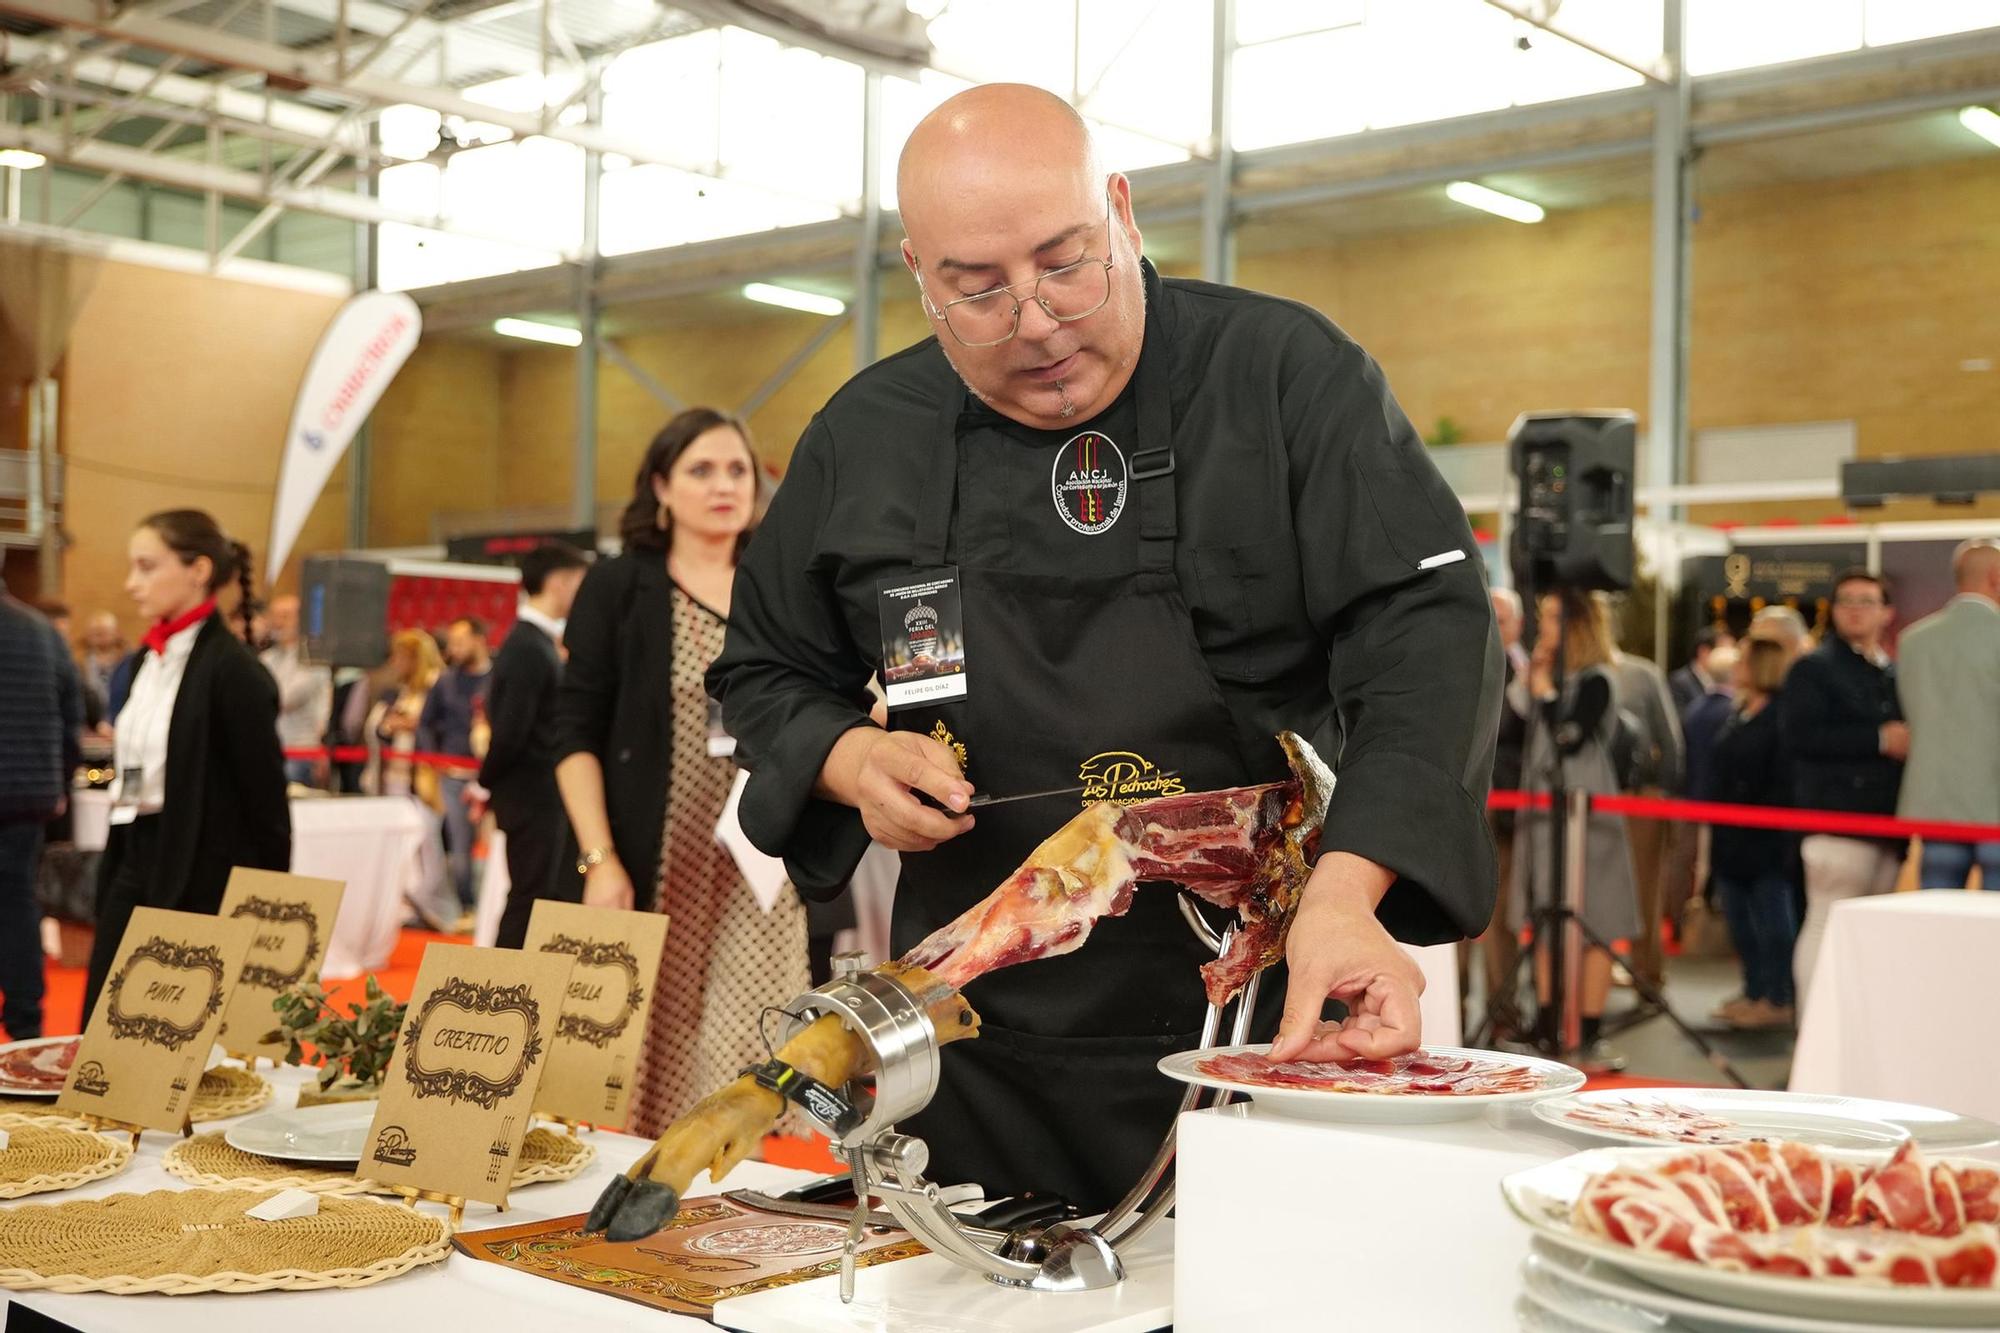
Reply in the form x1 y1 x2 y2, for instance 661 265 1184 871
56 907 256 1131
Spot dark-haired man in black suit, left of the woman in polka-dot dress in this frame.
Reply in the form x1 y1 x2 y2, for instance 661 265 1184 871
480 542 590 949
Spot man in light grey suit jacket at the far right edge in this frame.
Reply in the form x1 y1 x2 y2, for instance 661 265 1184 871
1896 538 2000 889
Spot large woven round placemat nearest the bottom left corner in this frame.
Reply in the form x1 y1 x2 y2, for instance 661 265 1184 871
0 1189 452 1295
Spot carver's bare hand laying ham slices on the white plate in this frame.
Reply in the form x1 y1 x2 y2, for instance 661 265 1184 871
1270 853 1424 1061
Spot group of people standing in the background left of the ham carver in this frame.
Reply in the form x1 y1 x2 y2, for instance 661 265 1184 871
0 408 854 1133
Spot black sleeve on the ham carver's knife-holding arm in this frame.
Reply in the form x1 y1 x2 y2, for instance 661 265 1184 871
708 420 870 897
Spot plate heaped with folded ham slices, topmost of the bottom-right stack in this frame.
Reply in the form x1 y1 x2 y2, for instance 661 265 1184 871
1502 1141 2000 1327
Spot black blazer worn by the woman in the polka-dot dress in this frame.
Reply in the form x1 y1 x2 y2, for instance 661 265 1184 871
556 550 674 907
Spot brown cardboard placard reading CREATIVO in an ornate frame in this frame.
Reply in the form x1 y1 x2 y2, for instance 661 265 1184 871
356 945 576 1205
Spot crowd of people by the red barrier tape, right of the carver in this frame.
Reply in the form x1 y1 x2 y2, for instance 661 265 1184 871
1480 540 2000 1069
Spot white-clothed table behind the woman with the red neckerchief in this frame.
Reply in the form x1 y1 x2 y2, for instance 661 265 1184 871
72 791 444 979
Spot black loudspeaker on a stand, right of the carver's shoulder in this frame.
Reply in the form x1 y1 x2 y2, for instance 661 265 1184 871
1508 412 1638 592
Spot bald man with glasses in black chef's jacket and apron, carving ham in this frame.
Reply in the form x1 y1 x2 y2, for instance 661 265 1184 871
708 86 1502 1209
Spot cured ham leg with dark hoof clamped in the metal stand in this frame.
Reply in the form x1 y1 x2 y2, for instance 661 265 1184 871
584 733 1332 1241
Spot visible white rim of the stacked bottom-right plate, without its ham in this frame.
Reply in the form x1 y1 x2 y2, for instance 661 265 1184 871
1500 1147 2000 1329
